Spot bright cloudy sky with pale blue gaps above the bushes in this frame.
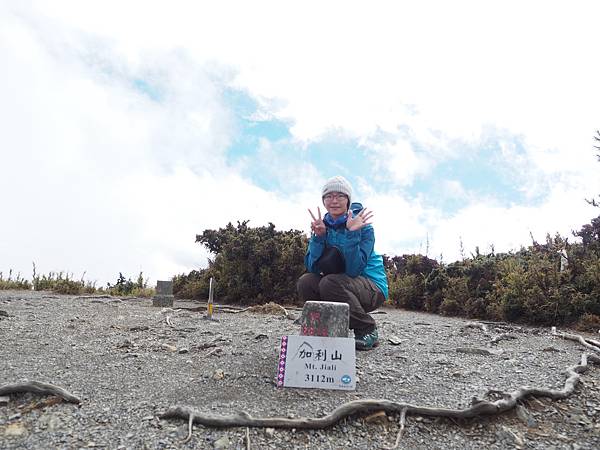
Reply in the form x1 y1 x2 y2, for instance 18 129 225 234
0 0 600 285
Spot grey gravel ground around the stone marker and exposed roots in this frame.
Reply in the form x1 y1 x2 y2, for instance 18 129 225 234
0 291 600 449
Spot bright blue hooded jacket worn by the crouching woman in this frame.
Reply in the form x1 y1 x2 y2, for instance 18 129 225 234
304 203 388 299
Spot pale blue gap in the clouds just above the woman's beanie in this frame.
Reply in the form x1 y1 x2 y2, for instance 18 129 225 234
223 89 542 215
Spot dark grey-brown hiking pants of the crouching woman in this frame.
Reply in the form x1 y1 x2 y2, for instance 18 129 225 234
297 273 385 334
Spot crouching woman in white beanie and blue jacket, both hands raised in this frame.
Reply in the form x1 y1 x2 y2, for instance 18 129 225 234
297 176 388 350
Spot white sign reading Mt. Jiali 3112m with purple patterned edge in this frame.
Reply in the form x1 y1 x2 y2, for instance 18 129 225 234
277 335 356 391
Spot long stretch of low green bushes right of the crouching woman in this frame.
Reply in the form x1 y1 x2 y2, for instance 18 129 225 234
385 217 600 326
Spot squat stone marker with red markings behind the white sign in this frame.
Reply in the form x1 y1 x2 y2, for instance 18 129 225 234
300 301 350 337
